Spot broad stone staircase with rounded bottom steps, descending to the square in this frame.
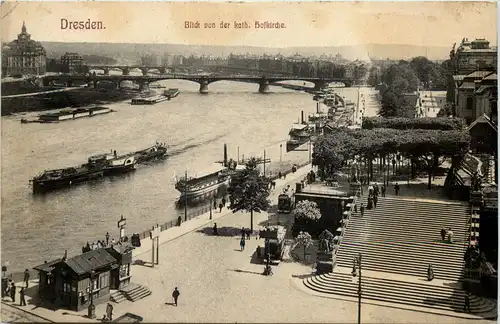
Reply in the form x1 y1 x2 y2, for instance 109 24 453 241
303 197 496 317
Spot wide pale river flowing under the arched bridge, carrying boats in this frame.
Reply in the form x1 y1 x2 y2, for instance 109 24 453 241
1 80 366 272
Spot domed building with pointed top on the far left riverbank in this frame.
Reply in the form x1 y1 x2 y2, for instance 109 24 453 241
2 22 47 75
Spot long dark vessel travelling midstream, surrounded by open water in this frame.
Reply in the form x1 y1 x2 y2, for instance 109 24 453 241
30 143 167 194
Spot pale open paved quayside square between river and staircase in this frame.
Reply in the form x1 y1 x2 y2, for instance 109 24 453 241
2 166 494 323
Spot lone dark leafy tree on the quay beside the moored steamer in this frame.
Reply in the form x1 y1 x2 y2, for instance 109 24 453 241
228 158 270 231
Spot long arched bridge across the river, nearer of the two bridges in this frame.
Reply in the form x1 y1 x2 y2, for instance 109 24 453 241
43 74 354 93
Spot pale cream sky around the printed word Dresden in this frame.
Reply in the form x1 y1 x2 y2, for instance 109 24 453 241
0 2 498 47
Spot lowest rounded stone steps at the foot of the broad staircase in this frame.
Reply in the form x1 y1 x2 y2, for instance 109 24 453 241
303 273 496 314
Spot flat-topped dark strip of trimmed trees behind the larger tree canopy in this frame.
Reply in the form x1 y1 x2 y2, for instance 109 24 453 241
362 117 465 130
